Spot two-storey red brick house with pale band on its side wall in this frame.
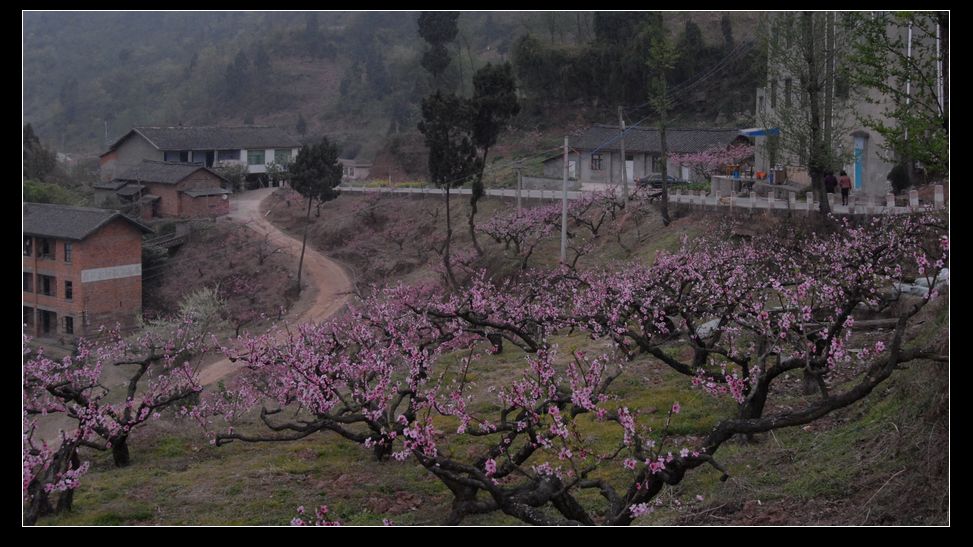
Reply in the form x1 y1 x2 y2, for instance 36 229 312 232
23 203 152 337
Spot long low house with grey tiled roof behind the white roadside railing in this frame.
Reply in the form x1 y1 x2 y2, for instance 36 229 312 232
544 124 749 183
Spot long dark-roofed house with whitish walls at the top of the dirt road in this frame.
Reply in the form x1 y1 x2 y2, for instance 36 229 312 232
99 125 301 181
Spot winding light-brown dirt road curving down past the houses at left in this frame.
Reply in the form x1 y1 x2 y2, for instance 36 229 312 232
199 188 352 386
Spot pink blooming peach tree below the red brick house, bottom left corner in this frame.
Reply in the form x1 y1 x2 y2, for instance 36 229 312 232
23 302 219 524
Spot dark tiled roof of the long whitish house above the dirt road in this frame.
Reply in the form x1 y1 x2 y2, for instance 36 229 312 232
110 125 301 150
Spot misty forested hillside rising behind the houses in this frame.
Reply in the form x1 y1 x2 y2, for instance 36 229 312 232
23 12 762 163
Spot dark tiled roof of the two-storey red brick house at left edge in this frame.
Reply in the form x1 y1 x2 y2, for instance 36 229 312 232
24 203 152 241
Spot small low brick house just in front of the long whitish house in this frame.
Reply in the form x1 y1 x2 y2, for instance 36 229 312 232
94 160 231 219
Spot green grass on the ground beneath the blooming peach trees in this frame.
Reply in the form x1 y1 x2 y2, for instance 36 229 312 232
34 196 948 525
